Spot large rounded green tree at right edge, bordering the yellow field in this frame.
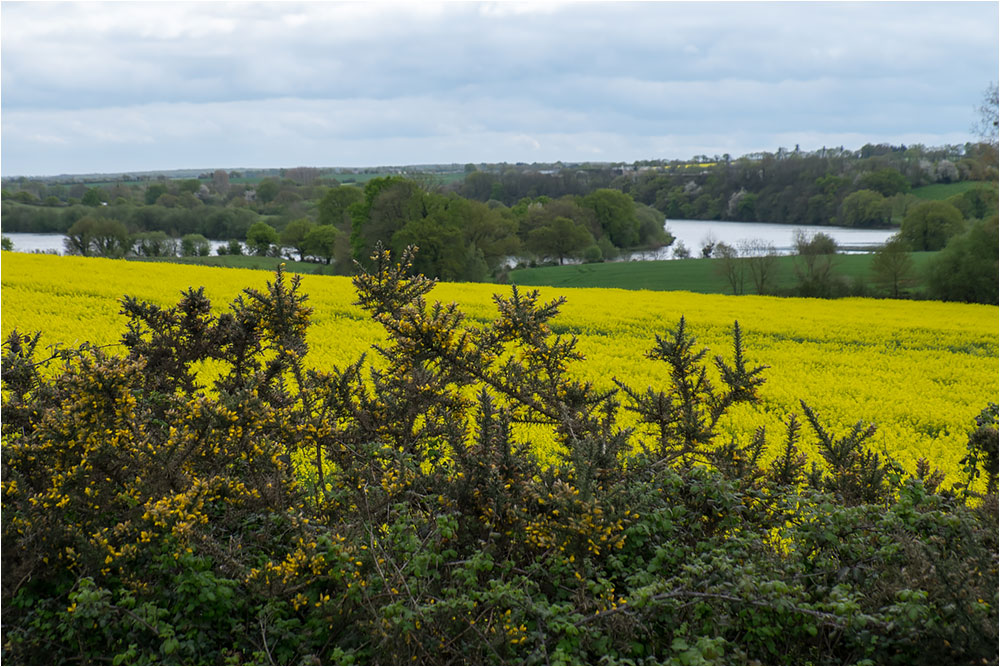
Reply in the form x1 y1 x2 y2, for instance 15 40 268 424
927 216 1000 304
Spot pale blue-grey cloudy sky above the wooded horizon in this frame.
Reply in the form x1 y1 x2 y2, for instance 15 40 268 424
0 1 1000 177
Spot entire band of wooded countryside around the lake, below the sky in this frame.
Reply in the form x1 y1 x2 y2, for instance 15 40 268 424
2 142 997 301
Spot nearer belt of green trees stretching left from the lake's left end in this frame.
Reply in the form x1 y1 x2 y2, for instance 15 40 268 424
4 176 670 281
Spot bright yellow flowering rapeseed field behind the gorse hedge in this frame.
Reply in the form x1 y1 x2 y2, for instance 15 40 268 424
0 252 998 483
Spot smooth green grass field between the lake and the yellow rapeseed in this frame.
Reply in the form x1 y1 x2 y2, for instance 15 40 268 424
510 252 936 294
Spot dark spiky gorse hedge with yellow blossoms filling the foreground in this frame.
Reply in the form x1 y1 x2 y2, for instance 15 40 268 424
2 251 998 664
